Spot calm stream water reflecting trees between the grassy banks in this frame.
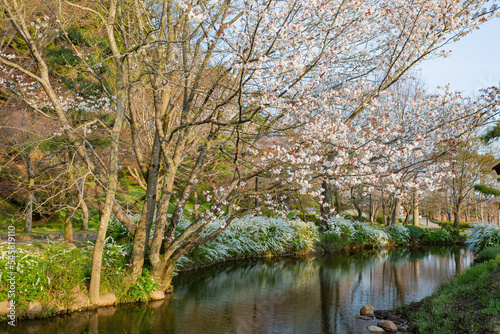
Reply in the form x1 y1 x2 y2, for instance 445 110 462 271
0 247 473 334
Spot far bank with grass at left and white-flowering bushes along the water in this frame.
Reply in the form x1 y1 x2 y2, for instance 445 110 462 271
0 217 460 321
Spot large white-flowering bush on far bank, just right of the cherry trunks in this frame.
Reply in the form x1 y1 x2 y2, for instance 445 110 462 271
176 215 318 269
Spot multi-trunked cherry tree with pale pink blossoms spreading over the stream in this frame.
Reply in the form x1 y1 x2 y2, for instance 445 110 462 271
0 0 495 303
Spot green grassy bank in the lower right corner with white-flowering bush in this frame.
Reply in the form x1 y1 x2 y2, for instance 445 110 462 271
376 223 500 334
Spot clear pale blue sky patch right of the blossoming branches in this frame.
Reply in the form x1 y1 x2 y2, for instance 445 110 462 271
420 18 500 96
